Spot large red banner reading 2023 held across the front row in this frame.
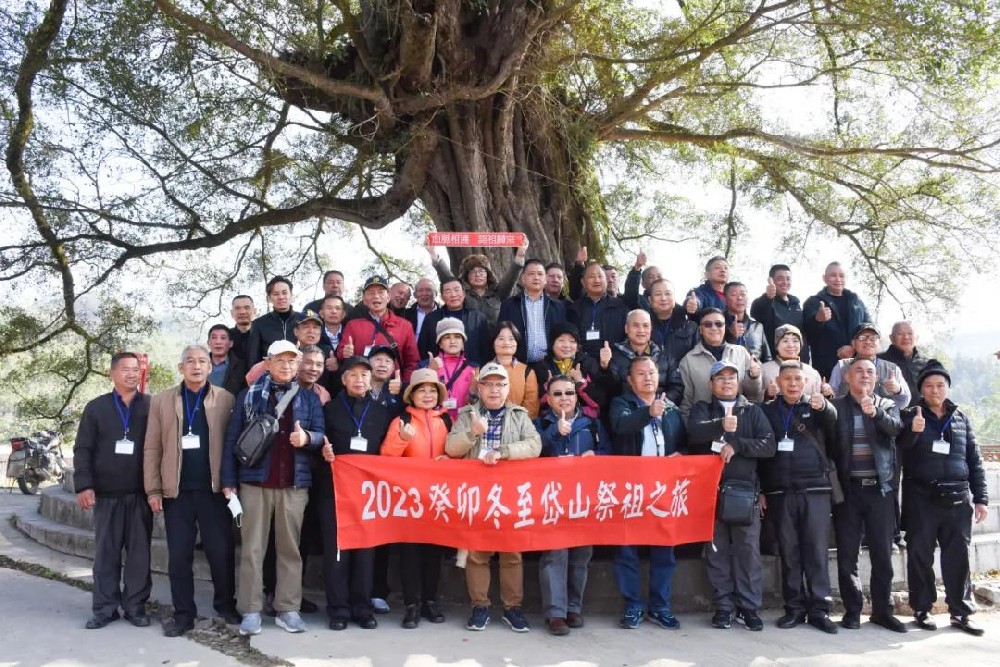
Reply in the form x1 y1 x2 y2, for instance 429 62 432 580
332 454 722 551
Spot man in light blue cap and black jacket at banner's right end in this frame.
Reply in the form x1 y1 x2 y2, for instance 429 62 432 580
688 361 775 631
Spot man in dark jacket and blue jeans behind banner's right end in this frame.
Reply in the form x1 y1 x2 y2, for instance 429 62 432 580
611 356 685 630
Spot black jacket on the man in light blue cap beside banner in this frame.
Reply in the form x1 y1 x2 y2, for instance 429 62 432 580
688 396 778 483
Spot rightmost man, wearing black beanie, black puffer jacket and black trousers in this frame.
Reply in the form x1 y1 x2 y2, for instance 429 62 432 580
899 361 989 635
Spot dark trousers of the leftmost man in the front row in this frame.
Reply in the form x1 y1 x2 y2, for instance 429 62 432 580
92 493 153 618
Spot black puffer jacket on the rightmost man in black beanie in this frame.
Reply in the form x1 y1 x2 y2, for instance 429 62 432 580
896 399 990 505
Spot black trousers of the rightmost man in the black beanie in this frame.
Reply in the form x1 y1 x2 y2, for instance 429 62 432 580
903 484 975 616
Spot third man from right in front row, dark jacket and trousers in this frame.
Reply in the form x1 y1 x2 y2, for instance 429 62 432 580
760 361 837 634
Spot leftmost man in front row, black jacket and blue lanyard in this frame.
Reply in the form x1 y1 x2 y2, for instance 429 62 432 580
73 352 153 630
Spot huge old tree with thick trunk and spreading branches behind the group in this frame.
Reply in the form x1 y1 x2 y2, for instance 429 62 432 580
0 0 1000 414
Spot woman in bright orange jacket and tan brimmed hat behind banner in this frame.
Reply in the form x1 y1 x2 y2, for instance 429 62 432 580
381 368 451 629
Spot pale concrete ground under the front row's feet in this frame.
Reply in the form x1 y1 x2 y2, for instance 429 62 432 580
0 489 1000 667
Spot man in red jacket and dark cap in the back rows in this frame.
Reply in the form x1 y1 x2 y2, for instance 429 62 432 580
337 276 420 382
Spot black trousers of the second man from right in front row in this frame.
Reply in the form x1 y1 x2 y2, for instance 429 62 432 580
833 481 895 616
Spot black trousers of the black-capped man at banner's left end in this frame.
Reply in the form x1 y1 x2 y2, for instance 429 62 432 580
316 490 375 619
